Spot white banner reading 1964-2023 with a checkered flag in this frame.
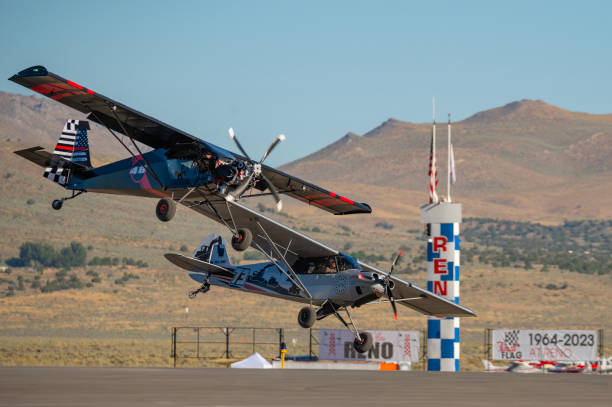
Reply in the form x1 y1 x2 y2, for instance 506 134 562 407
491 329 598 361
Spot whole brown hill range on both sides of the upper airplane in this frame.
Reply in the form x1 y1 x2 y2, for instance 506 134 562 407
0 92 612 222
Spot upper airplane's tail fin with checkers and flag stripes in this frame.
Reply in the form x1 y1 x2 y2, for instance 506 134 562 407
43 119 91 185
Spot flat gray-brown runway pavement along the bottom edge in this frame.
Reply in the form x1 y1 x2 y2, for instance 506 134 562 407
0 367 612 407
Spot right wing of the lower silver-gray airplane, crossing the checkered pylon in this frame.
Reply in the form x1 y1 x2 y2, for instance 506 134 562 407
359 261 476 317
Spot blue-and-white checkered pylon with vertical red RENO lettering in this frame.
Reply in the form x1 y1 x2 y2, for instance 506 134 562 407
421 202 461 372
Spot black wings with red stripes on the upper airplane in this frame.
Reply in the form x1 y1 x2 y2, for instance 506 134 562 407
9 65 372 215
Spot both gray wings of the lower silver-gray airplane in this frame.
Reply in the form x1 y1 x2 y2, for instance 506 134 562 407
186 197 476 317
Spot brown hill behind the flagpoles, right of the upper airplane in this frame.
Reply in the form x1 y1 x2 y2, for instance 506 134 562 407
281 100 612 220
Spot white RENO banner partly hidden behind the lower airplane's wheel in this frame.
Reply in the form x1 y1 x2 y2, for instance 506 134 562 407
319 329 420 362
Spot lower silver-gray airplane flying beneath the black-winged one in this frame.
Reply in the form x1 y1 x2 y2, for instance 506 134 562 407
165 202 475 353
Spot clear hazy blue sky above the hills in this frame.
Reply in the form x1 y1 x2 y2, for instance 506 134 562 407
0 0 612 165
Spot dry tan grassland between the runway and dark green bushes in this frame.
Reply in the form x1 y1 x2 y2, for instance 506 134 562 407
0 265 612 370
